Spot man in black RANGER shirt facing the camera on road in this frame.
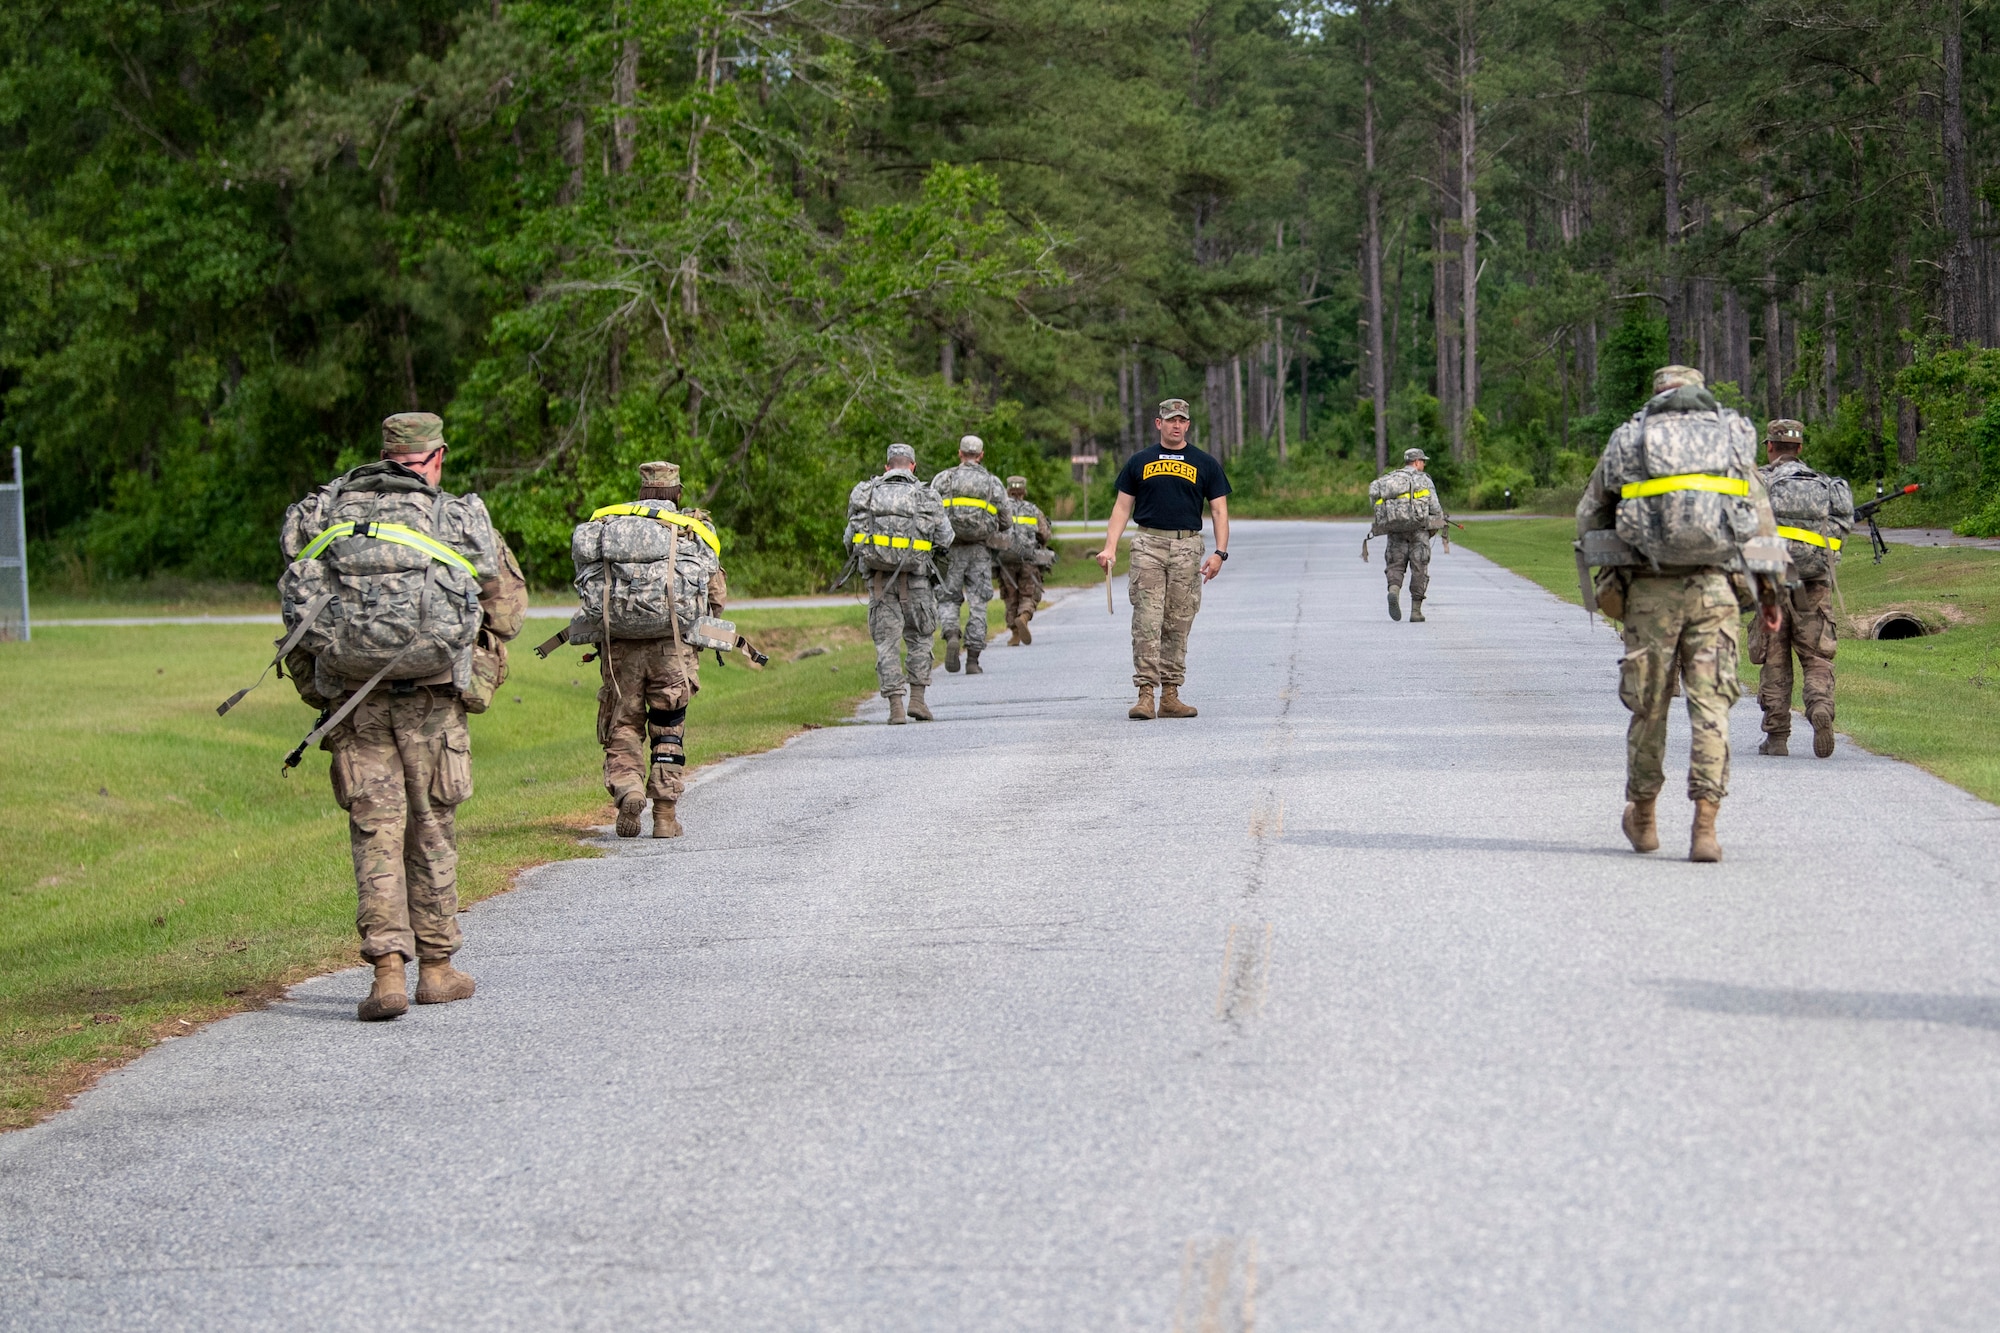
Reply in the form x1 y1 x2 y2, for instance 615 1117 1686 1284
1096 398 1230 723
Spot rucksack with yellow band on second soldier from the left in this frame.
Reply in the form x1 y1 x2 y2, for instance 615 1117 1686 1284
568 500 722 644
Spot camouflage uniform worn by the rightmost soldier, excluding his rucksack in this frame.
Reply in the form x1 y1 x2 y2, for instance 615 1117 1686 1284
1750 444 1854 741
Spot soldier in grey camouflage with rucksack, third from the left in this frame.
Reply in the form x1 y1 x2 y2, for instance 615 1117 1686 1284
842 444 956 727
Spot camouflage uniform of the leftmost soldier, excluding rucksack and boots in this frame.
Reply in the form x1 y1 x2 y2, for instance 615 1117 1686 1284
284 414 528 961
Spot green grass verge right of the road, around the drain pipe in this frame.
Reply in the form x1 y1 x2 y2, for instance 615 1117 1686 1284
1452 518 2000 801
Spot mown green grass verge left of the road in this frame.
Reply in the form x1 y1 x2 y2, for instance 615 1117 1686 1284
0 608 874 1129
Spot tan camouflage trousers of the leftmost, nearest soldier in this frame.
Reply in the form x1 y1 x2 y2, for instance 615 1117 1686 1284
320 687 472 959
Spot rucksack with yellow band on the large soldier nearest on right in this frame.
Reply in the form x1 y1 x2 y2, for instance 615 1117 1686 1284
1604 386 1758 566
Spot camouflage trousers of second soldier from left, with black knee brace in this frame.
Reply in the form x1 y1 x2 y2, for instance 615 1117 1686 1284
598 638 702 801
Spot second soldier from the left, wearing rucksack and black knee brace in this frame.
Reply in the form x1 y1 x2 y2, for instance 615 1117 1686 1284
568 462 728 839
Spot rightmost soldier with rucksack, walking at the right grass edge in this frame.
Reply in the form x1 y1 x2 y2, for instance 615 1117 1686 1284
1750 420 1854 759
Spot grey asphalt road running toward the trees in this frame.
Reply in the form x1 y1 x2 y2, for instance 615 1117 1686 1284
0 524 2000 1333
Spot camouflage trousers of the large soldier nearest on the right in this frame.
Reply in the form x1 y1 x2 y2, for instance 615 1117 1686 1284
1618 570 1742 801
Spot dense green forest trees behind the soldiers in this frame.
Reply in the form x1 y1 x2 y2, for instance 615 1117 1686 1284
19 0 2000 590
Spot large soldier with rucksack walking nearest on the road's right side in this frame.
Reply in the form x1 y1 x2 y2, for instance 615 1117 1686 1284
1576 366 1780 861
